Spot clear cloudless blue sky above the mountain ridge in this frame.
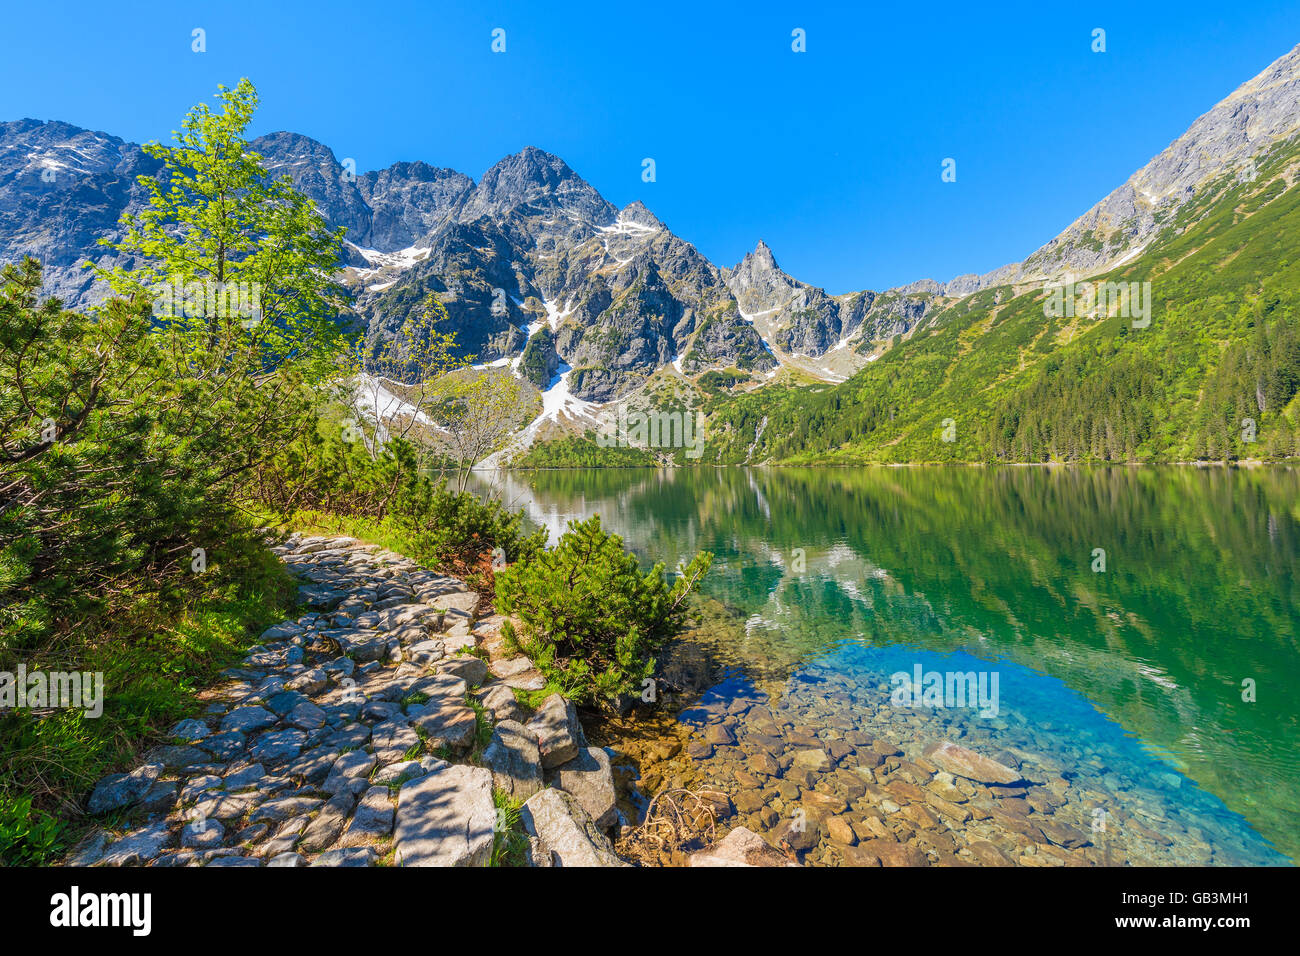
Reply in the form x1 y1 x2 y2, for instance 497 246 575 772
0 0 1300 293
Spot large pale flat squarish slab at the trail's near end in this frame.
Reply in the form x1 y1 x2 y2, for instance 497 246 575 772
394 765 497 866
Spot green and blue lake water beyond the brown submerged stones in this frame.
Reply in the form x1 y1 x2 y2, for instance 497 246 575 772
473 468 1300 864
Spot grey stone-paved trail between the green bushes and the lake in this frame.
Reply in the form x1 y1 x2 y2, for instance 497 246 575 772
68 535 625 866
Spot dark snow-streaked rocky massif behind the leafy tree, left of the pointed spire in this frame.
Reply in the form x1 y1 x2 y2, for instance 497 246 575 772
0 132 915 402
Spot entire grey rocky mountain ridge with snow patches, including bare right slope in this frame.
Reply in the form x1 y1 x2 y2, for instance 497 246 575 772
10 47 1300 402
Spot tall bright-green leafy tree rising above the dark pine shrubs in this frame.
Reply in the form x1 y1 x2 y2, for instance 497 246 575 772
94 79 347 378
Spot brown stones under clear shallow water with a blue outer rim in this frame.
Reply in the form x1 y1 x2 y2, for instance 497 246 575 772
610 655 1288 868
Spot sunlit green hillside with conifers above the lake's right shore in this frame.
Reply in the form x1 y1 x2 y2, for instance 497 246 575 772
701 134 1300 464
